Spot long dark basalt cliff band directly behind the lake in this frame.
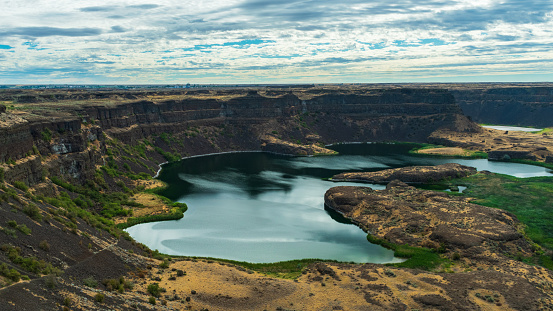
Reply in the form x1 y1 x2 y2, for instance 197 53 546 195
85 89 475 141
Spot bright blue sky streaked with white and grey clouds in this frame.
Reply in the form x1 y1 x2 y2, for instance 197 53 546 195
0 0 553 84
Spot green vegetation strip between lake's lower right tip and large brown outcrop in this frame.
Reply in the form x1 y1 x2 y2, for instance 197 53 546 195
367 234 449 271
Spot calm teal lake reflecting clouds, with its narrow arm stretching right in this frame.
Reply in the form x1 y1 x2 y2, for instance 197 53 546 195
127 144 553 263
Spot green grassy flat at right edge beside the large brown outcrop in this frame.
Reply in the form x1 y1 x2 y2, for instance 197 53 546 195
442 174 553 249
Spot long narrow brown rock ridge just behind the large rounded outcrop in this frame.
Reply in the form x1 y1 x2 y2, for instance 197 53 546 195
332 163 476 184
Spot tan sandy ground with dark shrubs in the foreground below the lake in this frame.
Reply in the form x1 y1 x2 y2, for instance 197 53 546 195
95 260 513 311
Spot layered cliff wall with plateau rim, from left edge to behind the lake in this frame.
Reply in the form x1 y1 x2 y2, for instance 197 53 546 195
0 88 478 184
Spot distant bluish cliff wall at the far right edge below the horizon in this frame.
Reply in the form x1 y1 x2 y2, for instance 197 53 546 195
451 86 553 127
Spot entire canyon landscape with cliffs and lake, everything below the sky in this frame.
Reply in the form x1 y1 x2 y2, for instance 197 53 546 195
0 83 553 310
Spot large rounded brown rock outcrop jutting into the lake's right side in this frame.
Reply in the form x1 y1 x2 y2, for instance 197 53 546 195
325 182 532 261
